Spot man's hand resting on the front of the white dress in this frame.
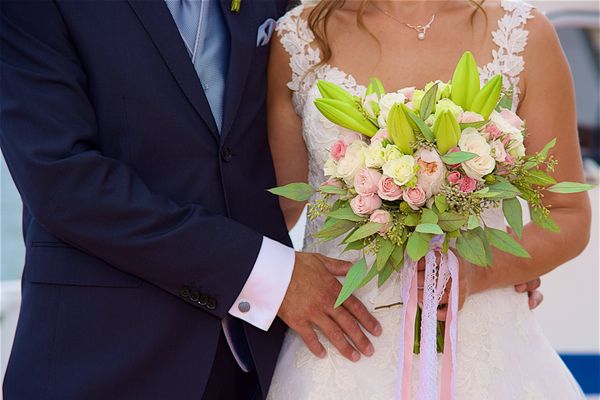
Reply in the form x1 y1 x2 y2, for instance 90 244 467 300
278 253 382 361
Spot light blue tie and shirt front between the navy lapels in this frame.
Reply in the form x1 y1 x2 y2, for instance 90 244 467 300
165 0 230 132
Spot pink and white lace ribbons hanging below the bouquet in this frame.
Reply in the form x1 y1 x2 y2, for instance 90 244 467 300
396 237 458 400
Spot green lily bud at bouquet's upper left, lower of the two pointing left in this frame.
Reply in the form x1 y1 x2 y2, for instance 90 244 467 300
315 99 377 137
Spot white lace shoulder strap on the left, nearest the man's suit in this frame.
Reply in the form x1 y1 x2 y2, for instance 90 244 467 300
275 4 321 114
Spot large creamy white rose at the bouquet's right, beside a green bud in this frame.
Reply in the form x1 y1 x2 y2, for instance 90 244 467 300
458 128 496 180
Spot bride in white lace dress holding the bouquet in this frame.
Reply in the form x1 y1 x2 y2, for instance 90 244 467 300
268 0 590 400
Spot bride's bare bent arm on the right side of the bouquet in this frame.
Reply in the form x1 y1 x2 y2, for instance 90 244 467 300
468 12 591 292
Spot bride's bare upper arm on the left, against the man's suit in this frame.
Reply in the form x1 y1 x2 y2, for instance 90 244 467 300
267 32 308 229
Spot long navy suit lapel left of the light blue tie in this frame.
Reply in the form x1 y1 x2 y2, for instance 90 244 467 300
127 0 220 140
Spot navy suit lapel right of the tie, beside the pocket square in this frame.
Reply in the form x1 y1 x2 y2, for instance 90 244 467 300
219 0 256 139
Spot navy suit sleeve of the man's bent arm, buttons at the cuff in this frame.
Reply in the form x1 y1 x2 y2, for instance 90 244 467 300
0 1 263 318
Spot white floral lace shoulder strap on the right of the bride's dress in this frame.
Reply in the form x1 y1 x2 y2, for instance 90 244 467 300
480 0 533 111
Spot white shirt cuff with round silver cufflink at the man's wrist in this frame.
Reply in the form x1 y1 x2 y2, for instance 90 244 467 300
229 237 296 331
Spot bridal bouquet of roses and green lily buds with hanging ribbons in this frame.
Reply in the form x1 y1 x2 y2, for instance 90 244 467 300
271 52 590 398
